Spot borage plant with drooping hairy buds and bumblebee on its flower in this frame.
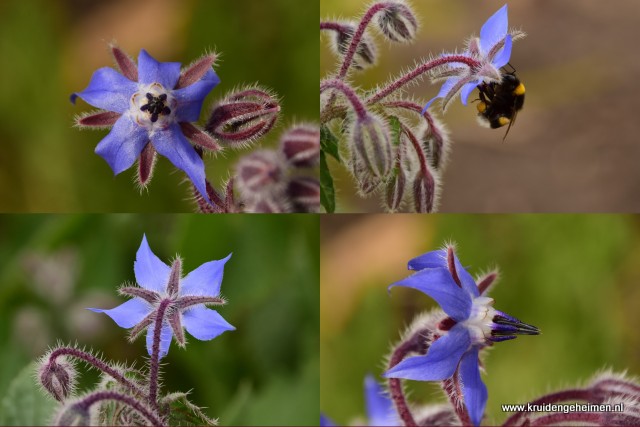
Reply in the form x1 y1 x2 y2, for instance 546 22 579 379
320 0 524 212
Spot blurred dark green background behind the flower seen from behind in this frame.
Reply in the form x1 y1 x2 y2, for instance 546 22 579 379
0 214 319 425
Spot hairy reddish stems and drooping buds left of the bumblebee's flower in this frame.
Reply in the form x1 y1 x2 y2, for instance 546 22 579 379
320 0 456 212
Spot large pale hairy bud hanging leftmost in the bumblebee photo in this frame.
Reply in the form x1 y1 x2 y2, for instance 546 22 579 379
350 114 393 179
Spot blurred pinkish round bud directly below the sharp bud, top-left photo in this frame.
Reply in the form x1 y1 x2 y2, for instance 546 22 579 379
235 150 286 198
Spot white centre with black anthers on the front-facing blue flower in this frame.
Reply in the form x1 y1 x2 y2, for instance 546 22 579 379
130 83 178 131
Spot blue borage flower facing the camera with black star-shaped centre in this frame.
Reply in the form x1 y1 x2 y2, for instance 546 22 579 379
71 46 220 201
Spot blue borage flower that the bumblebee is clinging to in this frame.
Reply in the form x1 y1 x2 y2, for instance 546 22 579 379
422 4 525 113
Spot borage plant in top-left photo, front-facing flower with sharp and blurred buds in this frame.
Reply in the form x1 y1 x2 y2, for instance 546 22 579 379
71 45 320 213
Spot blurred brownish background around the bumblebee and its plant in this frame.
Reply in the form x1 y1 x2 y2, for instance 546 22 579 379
320 0 640 213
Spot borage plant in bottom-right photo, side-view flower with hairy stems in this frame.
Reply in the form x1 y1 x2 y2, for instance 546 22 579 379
320 245 640 426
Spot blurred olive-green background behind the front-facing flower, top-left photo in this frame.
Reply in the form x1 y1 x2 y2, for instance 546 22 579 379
0 0 319 212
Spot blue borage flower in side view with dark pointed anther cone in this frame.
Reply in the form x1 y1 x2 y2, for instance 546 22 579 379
384 247 540 425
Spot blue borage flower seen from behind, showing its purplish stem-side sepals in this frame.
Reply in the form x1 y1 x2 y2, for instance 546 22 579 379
89 236 235 358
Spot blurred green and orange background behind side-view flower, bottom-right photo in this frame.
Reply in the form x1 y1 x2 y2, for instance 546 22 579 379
320 214 640 425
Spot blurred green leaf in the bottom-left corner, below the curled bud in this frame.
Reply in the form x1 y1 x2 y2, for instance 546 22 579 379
0 363 58 426
